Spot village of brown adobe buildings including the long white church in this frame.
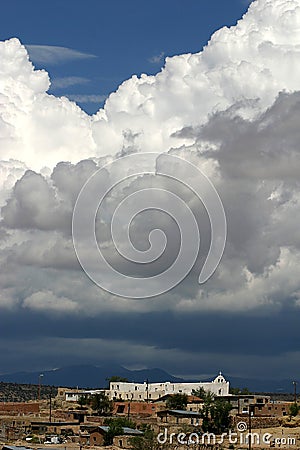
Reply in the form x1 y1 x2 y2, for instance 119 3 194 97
0 373 292 450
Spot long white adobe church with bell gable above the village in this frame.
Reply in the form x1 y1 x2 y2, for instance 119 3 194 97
106 372 229 401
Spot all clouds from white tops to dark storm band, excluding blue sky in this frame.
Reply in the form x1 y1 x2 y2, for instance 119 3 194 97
0 0 300 377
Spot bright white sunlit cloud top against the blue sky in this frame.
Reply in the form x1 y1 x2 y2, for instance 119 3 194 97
0 0 300 170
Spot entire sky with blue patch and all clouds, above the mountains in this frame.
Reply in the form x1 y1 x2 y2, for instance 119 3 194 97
0 0 300 380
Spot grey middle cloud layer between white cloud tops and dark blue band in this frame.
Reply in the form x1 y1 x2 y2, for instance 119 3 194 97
2 93 300 315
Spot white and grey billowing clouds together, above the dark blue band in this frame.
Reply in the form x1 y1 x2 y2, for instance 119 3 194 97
0 0 300 378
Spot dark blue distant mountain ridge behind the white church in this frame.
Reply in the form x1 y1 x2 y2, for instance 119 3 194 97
0 364 293 394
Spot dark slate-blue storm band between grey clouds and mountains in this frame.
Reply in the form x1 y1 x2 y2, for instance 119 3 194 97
0 311 299 377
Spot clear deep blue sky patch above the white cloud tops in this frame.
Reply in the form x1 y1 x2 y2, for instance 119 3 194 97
0 0 252 114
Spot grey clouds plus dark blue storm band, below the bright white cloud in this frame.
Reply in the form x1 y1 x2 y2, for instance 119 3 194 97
0 93 300 376
